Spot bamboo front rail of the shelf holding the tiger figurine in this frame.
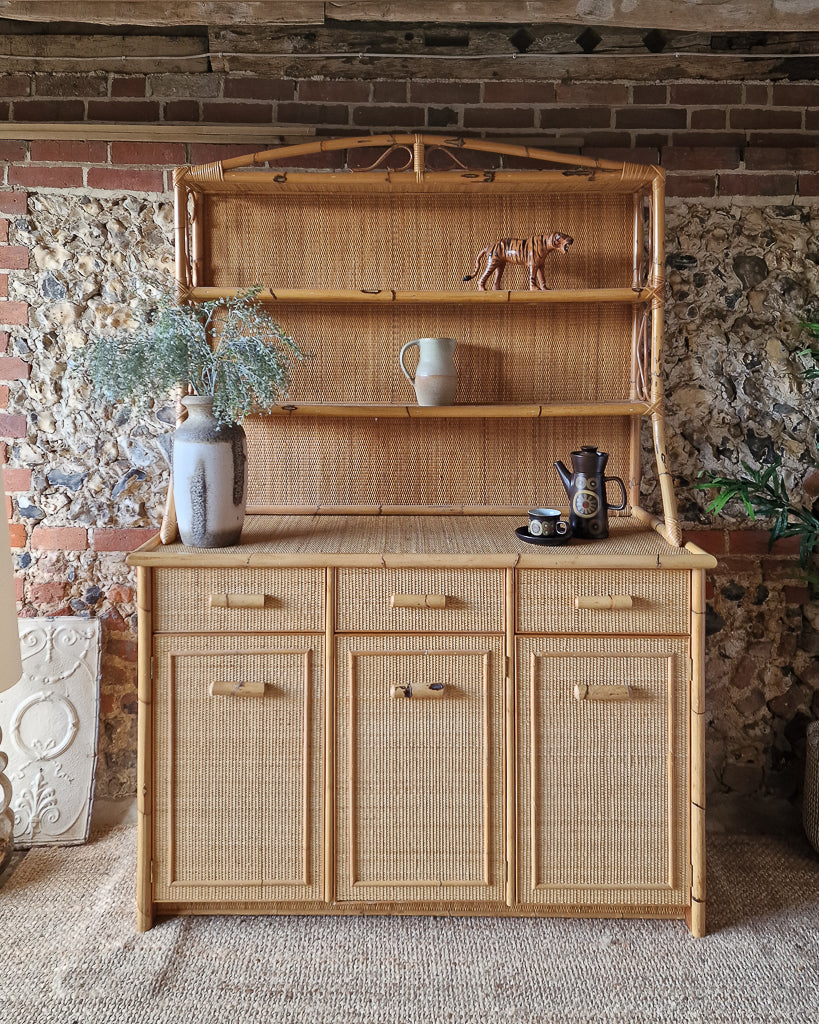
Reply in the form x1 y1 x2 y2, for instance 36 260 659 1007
187 287 654 305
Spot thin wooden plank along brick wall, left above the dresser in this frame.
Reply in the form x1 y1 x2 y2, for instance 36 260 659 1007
0 121 315 144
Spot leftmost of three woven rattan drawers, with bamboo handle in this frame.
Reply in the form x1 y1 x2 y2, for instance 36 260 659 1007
154 568 325 633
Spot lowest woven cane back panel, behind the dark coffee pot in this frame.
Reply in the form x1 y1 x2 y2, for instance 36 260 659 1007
245 416 630 509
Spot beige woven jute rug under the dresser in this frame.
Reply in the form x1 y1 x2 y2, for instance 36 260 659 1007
0 826 819 1024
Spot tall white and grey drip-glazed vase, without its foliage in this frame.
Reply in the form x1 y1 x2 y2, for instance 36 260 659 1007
173 395 248 548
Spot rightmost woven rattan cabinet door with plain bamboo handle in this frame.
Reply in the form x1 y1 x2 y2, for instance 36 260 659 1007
517 637 690 912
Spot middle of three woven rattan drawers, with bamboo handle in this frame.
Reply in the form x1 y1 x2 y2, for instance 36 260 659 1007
336 568 505 633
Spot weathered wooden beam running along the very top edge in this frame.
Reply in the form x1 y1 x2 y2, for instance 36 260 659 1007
0 0 819 34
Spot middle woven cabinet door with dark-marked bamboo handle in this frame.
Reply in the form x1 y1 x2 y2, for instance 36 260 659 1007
336 636 505 904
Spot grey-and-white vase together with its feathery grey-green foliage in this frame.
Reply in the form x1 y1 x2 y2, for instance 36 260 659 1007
82 288 302 548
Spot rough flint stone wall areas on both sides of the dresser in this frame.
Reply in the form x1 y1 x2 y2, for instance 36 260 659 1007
8 193 819 824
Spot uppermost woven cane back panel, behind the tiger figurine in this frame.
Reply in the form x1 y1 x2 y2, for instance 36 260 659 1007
200 192 634 292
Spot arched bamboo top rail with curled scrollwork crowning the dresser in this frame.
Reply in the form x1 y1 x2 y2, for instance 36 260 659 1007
181 133 664 193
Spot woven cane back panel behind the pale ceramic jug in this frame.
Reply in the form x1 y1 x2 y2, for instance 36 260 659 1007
268 302 634 406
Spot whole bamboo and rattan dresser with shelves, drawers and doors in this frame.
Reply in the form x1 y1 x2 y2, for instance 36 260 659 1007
129 135 715 935
